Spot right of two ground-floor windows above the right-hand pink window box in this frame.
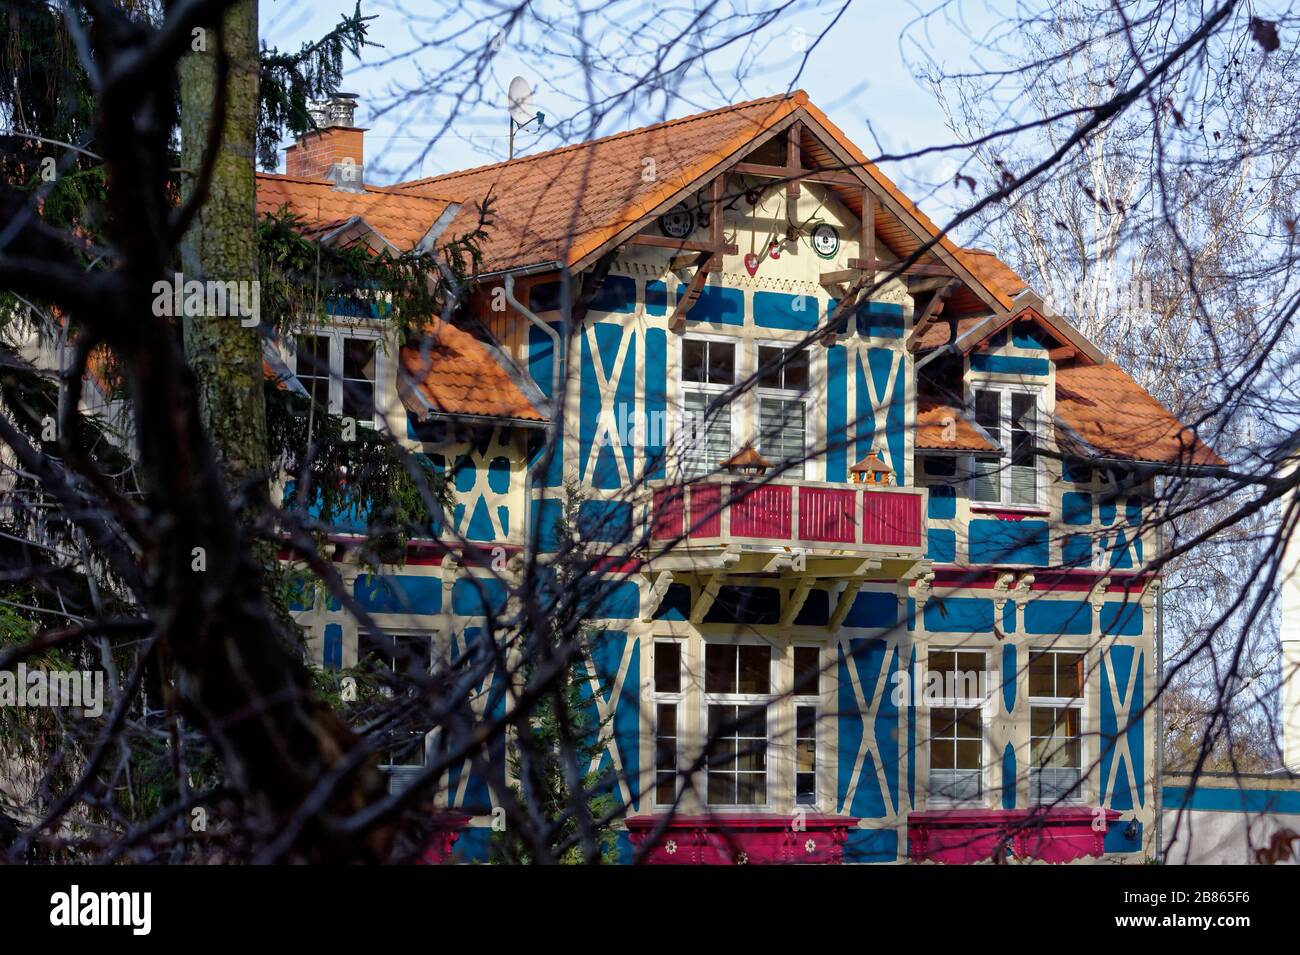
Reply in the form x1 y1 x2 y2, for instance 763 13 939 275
1030 650 1084 803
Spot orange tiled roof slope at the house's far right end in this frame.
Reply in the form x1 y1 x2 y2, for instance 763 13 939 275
1056 363 1225 466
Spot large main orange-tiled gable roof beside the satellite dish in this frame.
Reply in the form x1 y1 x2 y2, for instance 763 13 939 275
395 91 1011 312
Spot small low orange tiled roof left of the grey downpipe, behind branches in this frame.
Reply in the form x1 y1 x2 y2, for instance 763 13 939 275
398 318 546 422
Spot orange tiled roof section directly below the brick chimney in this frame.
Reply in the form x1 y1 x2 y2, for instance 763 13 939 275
257 173 456 252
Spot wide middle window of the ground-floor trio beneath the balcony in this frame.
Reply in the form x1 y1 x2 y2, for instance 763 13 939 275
705 643 772 806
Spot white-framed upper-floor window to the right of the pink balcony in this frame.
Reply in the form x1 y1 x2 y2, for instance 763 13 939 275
971 388 1043 504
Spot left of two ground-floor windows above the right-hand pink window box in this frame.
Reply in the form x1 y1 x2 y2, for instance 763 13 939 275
926 650 985 803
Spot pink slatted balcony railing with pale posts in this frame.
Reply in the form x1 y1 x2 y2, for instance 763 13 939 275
650 478 926 554
